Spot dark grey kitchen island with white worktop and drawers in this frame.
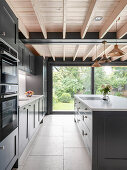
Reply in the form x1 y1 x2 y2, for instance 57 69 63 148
74 95 127 170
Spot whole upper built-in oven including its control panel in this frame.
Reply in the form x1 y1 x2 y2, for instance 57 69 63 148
0 38 18 84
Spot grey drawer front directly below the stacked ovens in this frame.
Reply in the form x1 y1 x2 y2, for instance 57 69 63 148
0 128 18 170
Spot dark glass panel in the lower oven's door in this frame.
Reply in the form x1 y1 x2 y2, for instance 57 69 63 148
1 98 17 128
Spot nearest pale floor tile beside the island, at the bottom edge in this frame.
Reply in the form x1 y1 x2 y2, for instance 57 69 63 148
64 148 91 170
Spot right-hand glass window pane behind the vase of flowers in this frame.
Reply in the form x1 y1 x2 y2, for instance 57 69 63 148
94 66 127 97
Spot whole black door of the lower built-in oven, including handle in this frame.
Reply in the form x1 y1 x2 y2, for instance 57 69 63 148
0 95 18 140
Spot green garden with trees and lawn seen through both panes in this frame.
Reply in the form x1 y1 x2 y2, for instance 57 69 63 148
53 66 127 111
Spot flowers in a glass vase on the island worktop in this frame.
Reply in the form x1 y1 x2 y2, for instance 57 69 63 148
100 84 112 100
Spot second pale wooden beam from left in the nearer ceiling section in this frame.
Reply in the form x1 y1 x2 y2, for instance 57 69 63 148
31 0 47 39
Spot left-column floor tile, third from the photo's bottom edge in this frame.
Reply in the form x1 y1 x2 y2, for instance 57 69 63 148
38 125 63 137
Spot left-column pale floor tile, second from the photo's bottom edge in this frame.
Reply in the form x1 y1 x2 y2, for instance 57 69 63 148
30 136 63 155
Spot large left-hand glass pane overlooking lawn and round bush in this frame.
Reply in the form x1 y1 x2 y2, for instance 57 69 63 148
53 66 91 111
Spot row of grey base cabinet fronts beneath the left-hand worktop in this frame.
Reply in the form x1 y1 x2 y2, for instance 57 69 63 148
19 97 44 156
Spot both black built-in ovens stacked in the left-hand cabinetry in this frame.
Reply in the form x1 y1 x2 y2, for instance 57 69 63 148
0 39 18 140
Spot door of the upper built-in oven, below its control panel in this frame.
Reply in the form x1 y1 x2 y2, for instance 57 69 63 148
1 58 18 84
